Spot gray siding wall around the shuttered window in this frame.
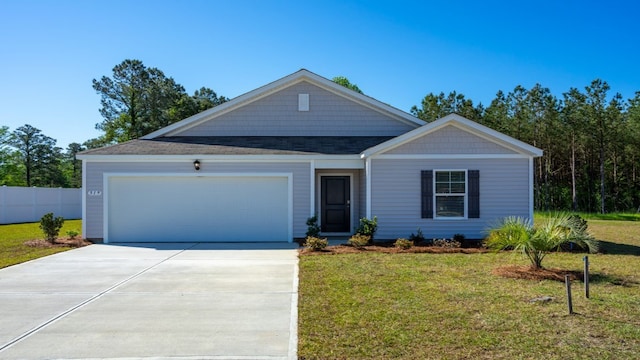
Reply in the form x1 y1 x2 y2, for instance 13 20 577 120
371 158 530 239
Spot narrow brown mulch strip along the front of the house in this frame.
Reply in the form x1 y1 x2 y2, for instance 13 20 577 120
300 245 488 255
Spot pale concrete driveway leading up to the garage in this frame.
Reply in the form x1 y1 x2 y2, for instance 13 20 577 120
0 243 298 359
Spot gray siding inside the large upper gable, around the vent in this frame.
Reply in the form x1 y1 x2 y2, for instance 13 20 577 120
172 82 418 136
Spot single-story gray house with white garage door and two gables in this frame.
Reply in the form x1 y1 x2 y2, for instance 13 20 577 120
78 69 542 243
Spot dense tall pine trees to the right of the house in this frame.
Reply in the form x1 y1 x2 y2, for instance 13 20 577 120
411 79 640 213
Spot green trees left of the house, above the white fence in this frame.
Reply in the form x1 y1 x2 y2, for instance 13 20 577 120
0 59 228 187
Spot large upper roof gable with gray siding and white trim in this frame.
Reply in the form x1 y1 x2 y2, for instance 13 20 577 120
142 69 424 139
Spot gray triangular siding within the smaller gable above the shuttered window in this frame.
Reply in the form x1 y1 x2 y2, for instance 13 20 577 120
385 125 515 154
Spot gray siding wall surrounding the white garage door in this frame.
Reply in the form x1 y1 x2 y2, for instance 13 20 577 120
83 160 311 239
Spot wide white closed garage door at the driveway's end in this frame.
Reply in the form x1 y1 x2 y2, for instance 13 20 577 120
105 176 290 242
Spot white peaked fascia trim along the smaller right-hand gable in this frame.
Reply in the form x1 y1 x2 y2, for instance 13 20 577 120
361 114 542 158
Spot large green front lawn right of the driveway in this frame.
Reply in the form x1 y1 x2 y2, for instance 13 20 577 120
298 220 640 359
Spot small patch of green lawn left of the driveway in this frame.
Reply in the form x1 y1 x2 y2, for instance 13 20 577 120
0 220 82 269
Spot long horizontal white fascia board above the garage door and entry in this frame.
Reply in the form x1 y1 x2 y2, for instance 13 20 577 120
78 154 362 164
